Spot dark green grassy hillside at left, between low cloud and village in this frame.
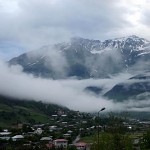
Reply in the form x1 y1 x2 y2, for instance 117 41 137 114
0 96 68 126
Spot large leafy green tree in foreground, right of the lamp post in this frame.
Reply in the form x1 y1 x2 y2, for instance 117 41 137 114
91 114 133 150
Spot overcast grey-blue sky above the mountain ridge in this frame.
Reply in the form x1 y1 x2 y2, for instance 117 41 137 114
0 0 150 59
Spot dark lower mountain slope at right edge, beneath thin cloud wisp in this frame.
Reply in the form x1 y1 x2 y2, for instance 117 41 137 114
104 80 150 101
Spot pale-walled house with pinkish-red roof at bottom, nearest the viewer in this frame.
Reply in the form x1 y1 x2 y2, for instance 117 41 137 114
54 139 68 148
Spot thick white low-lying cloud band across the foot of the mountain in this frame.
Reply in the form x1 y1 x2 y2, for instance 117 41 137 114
0 59 150 112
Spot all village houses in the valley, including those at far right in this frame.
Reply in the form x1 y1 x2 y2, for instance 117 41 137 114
0 111 150 150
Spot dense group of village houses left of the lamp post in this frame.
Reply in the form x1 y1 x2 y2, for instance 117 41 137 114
0 110 89 150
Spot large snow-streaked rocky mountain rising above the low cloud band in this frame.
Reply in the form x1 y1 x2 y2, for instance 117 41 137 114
9 35 150 79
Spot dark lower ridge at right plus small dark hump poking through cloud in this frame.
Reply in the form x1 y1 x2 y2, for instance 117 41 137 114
85 73 150 102
